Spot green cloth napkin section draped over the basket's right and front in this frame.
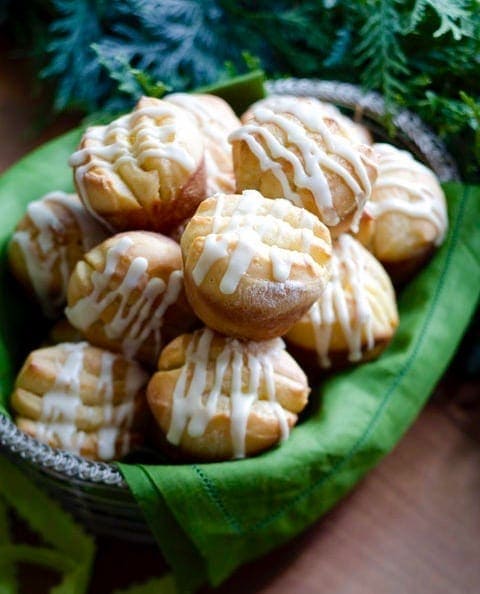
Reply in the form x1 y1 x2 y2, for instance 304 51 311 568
119 183 480 591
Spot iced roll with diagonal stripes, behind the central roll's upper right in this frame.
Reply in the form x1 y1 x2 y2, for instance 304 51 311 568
229 96 377 236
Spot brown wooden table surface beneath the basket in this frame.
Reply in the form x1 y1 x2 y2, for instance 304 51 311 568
0 47 480 594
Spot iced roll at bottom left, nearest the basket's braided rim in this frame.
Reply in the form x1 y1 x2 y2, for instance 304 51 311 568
11 342 149 460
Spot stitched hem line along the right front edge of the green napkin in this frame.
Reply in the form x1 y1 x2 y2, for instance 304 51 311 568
193 186 471 535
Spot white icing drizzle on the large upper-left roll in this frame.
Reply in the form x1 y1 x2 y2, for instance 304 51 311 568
68 101 198 224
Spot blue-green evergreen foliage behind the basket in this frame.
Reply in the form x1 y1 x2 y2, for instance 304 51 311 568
0 0 480 179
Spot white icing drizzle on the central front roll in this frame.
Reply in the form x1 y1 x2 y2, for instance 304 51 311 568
192 190 322 295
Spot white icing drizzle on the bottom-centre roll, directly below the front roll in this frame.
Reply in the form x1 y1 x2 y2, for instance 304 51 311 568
167 328 289 458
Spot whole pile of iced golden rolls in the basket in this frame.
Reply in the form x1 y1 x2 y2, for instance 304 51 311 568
9 93 447 461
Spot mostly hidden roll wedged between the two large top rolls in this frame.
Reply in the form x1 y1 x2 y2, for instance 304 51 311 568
164 93 241 196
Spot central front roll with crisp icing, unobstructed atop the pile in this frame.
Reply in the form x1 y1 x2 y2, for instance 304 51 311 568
181 190 331 340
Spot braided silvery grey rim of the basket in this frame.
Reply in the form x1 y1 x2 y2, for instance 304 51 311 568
0 78 460 490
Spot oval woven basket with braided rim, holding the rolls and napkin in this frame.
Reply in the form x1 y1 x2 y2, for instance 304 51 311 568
0 78 459 542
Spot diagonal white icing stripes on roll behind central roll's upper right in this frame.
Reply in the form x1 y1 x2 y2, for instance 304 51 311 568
229 96 375 226
